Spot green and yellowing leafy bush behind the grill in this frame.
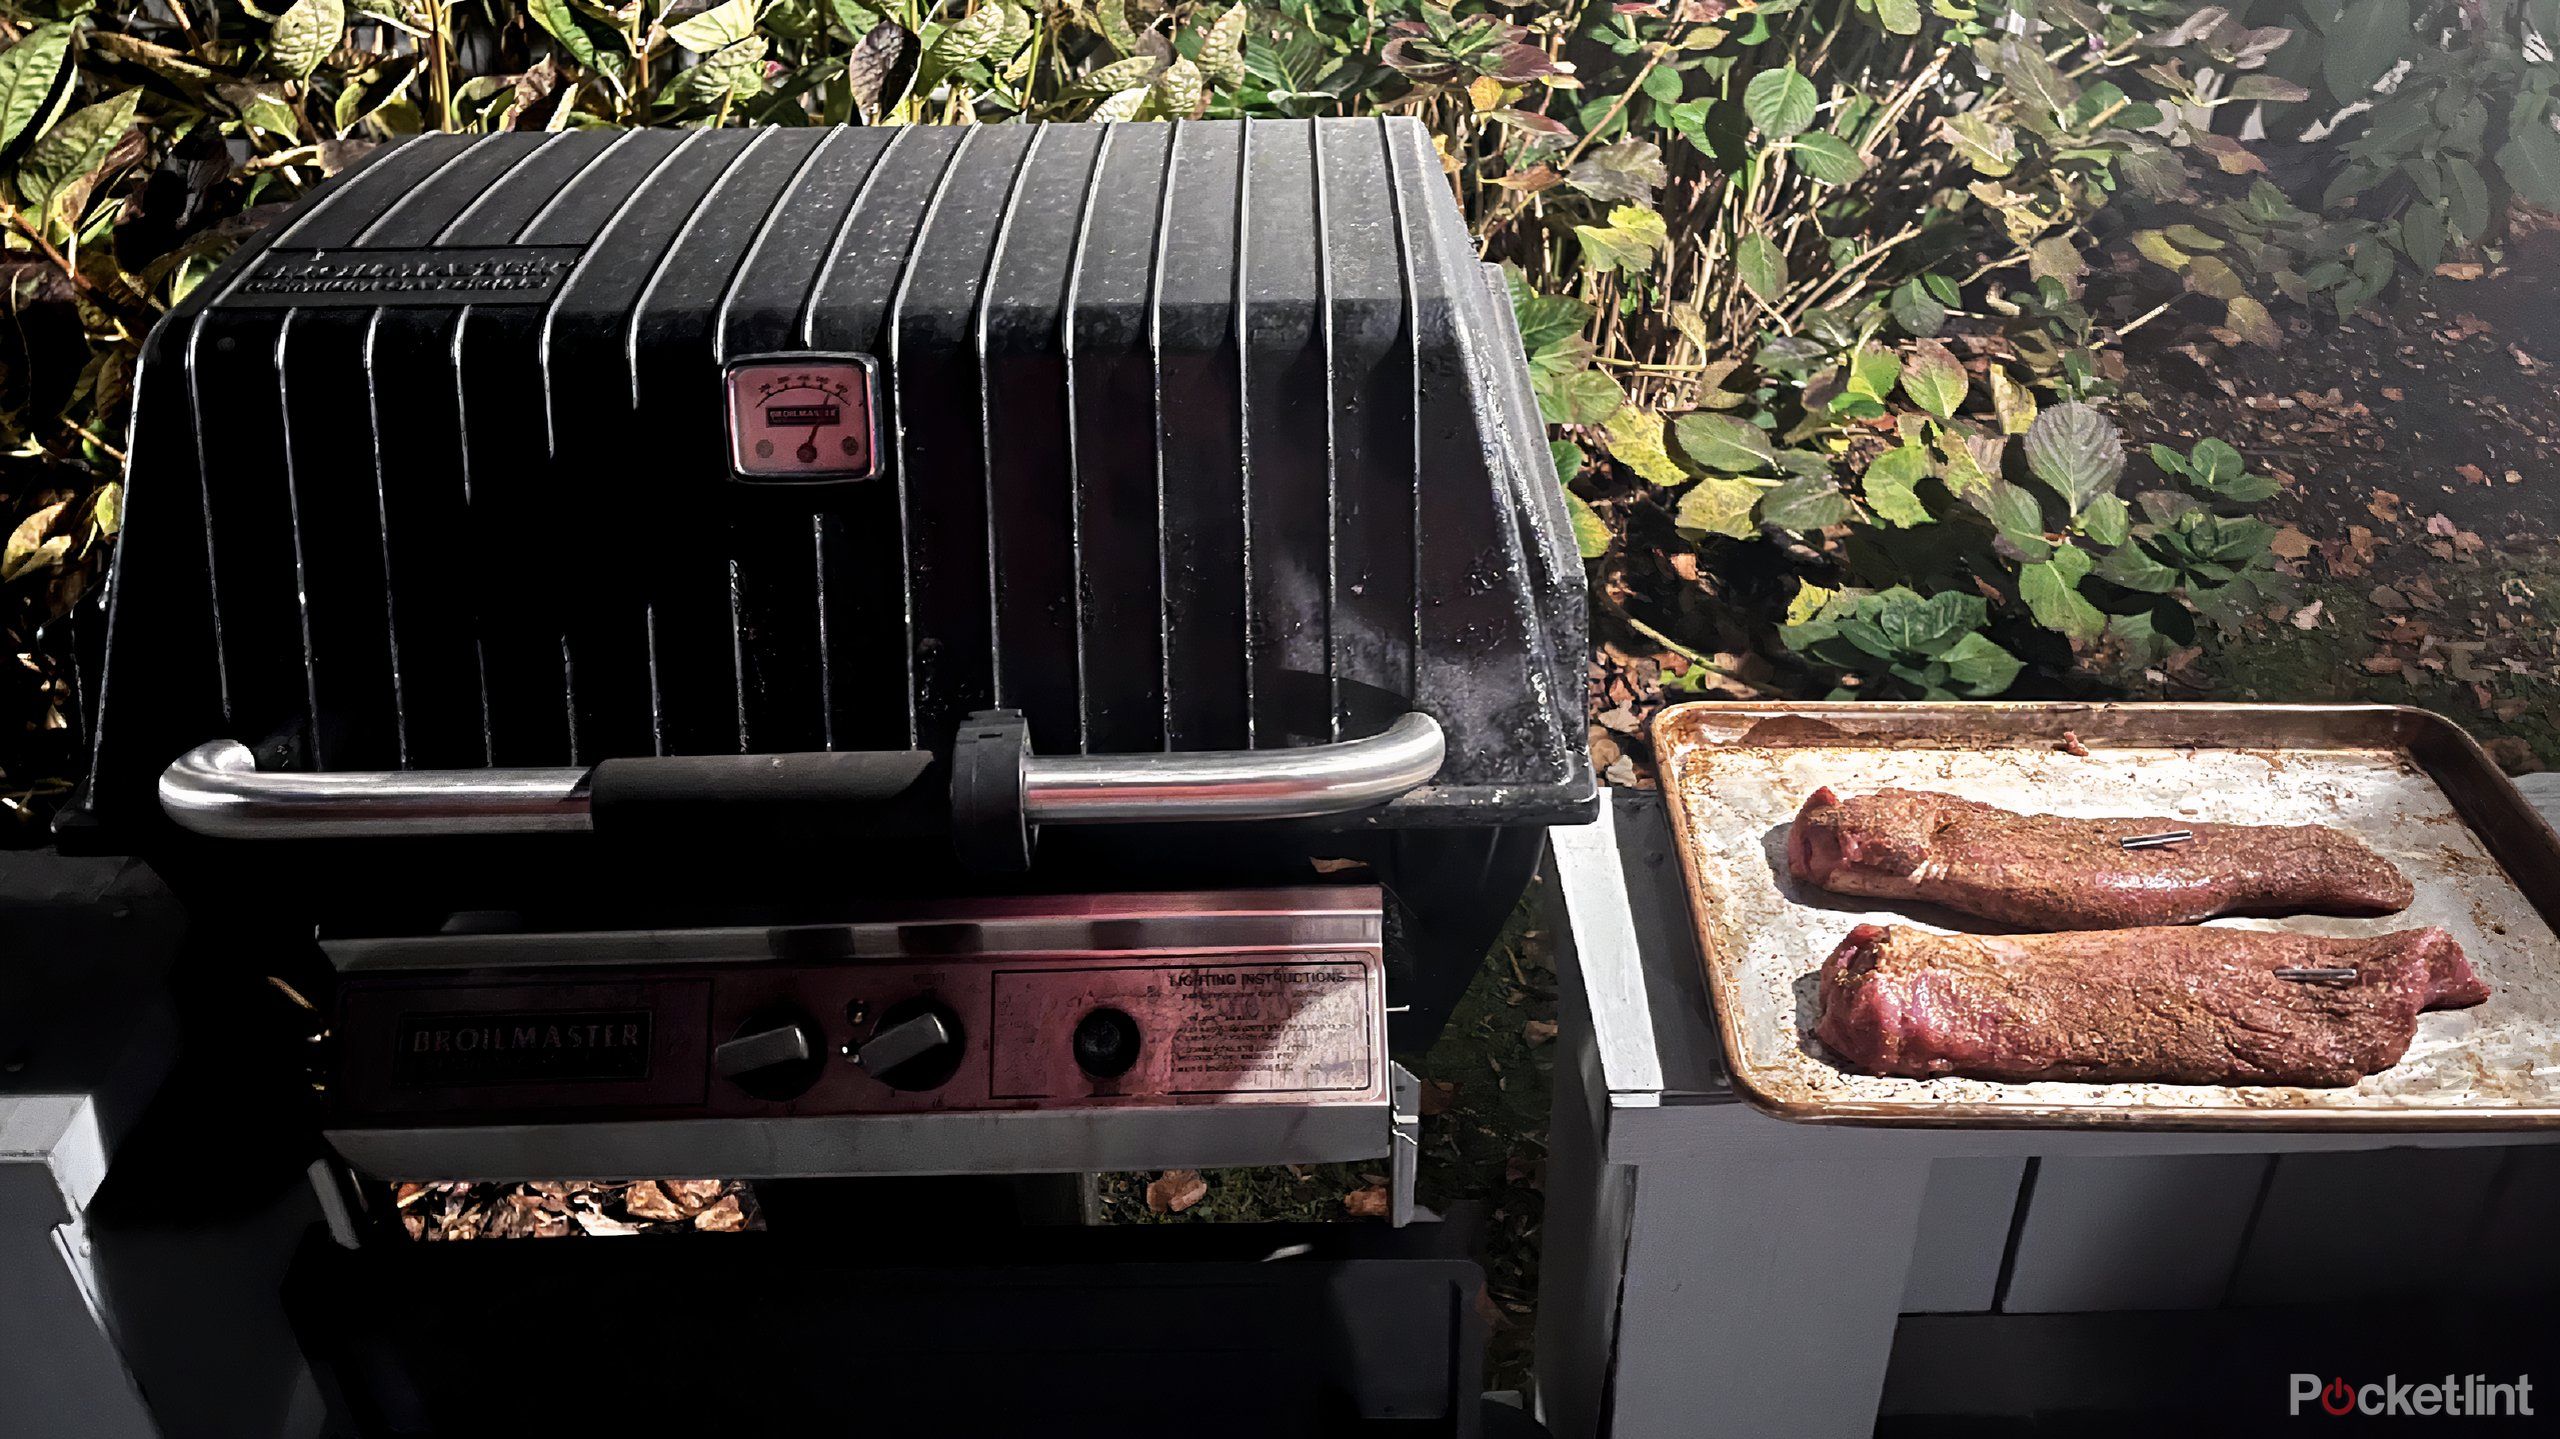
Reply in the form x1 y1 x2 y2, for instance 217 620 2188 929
0 0 2560 801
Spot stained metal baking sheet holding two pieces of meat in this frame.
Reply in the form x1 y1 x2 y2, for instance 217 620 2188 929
1654 704 2560 1129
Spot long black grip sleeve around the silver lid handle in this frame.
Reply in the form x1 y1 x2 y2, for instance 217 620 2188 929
586 750 952 840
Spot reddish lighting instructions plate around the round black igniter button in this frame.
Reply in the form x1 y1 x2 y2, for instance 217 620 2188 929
993 960 1377 1098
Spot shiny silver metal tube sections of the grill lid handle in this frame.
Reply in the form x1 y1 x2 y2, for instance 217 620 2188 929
159 714 1446 840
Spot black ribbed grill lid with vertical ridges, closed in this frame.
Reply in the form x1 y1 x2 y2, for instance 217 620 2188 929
87 120 1592 827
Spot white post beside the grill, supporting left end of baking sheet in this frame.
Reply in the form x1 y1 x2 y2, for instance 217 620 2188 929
1539 807 1930 1439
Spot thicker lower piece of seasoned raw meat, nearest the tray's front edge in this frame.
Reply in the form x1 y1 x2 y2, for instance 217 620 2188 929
1815 924 2488 1086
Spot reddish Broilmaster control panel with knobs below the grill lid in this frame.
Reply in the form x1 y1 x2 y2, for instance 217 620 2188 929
330 886 1388 1124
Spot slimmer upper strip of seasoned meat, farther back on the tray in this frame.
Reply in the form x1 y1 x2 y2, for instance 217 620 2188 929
1787 786 2414 929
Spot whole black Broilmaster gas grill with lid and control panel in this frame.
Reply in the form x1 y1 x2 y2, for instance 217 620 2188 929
61 120 1595 1423
